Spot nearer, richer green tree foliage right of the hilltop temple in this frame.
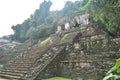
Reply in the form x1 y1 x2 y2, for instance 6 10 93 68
80 0 120 36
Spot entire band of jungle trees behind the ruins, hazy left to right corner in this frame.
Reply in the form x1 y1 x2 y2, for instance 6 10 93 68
11 0 120 42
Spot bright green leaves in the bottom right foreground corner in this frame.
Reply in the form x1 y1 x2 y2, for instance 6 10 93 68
103 59 120 80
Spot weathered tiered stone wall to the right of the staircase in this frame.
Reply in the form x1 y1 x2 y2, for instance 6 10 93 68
38 27 120 80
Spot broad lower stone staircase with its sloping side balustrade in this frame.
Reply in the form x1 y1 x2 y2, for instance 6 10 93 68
0 46 65 80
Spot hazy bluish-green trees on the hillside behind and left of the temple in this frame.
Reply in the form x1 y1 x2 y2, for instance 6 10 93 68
11 0 88 42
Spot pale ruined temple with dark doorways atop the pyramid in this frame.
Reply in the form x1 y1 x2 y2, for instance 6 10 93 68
57 14 90 32
